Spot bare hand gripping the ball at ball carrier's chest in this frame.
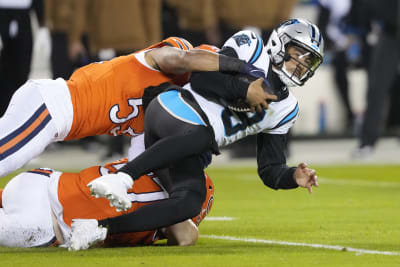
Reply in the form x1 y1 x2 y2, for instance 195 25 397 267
246 78 278 112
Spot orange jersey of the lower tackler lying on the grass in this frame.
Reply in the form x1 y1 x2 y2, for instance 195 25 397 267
58 159 167 246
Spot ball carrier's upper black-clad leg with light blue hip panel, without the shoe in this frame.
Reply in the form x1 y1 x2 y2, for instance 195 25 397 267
121 91 213 180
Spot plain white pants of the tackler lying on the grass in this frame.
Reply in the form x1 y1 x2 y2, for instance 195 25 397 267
0 172 56 247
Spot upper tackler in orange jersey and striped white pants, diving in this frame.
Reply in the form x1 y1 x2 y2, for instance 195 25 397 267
0 37 276 177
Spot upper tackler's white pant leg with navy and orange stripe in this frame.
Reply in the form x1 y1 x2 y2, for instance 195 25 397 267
0 81 57 177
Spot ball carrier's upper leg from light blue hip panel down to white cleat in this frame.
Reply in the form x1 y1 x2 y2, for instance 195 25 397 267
88 91 214 210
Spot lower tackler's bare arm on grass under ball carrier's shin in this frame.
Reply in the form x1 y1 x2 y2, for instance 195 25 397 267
161 219 199 246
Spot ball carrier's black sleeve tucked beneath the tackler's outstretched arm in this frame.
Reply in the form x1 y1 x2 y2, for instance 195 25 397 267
190 71 249 100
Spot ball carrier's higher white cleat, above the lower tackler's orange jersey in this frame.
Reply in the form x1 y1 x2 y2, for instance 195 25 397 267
87 172 133 211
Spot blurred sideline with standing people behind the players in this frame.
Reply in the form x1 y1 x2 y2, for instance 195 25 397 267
0 0 400 168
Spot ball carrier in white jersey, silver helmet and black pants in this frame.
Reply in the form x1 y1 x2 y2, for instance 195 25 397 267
70 19 323 251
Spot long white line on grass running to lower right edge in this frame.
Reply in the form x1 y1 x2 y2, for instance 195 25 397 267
200 235 400 256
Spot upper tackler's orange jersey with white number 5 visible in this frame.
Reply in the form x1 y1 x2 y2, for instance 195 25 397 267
65 37 193 140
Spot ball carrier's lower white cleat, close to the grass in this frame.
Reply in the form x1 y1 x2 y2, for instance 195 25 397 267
68 219 107 251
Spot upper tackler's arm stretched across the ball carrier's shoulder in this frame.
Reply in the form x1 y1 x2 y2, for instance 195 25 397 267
145 46 249 74
